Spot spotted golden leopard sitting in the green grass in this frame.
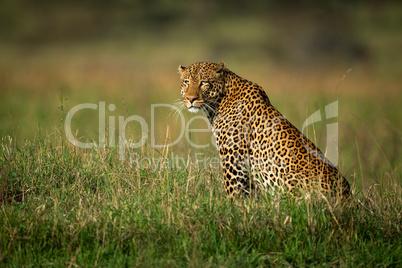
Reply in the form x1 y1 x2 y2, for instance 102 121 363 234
179 61 351 199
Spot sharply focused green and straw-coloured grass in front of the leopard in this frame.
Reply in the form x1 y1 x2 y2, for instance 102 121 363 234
0 133 402 267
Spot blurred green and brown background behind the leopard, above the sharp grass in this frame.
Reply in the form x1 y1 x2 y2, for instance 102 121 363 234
0 0 402 184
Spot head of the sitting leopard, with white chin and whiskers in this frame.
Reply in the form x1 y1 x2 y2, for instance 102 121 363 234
179 61 226 113
